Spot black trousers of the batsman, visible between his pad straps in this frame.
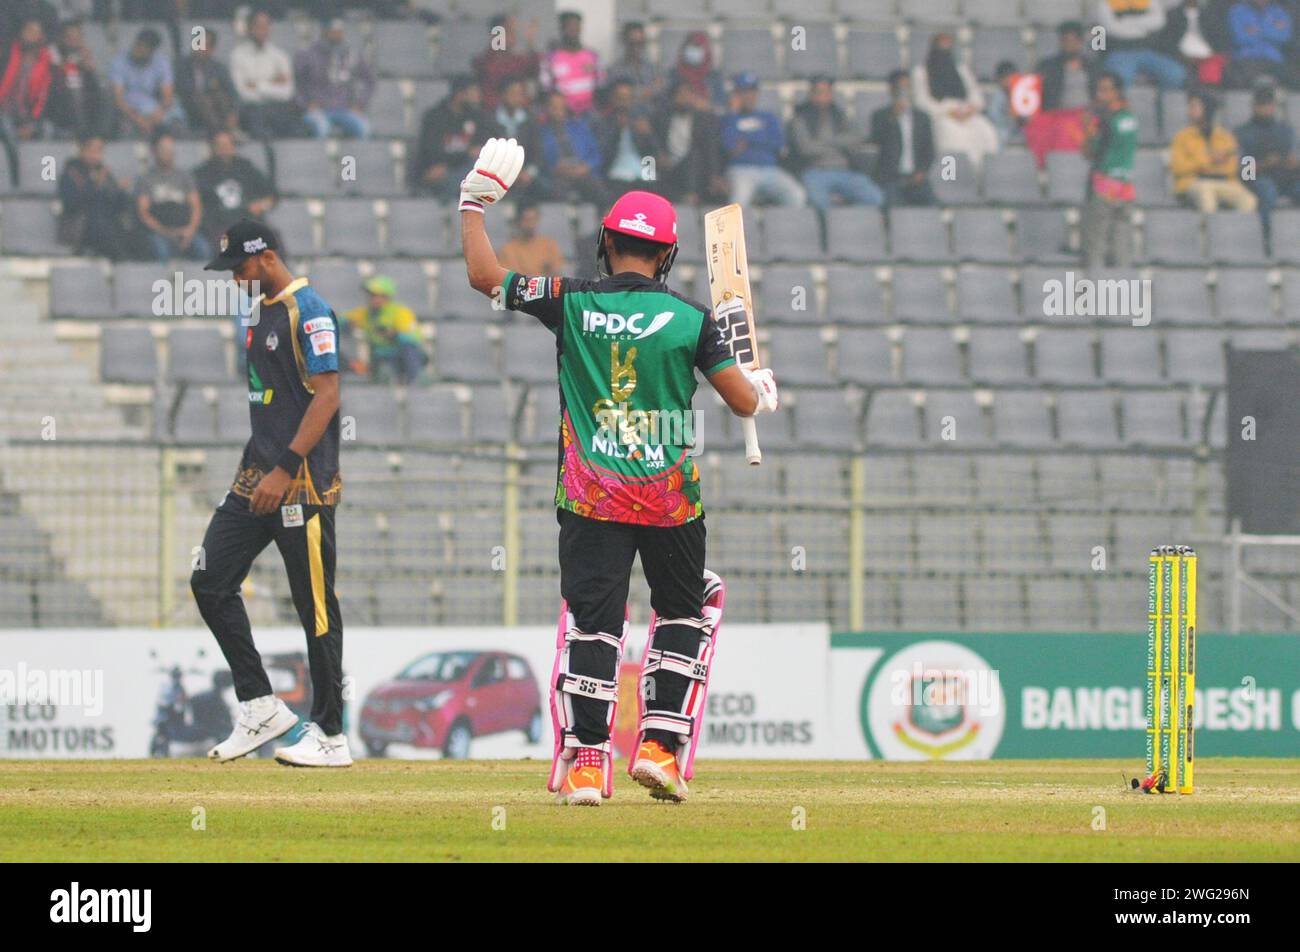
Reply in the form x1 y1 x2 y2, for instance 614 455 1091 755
558 510 705 750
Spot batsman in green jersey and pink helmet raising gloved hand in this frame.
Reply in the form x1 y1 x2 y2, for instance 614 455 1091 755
460 139 777 806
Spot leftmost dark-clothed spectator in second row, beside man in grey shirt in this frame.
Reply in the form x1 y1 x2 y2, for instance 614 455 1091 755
59 135 131 259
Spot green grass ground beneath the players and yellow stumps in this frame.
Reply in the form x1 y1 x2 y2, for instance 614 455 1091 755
0 758 1300 862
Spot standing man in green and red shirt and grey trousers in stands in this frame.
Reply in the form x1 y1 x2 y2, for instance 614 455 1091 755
1083 70 1138 269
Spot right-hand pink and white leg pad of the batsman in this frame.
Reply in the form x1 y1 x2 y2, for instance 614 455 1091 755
628 568 727 780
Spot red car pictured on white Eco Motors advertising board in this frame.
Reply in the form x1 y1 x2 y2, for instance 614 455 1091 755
360 652 542 760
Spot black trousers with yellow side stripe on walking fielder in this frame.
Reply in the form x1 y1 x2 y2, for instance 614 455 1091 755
190 493 343 735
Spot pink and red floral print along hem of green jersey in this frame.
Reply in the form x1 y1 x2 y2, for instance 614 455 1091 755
555 416 705 525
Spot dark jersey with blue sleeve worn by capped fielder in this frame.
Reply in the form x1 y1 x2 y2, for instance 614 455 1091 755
231 278 343 506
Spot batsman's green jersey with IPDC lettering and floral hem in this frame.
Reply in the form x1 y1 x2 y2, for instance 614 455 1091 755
504 272 735 525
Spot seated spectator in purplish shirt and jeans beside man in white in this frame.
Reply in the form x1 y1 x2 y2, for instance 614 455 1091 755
294 20 374 139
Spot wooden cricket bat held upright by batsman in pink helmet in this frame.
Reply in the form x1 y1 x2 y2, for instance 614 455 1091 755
705 204 763 466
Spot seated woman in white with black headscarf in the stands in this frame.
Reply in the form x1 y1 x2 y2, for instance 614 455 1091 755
911 33 997 172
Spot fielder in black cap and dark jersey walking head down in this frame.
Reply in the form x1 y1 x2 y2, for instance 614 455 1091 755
190 220 352 767
